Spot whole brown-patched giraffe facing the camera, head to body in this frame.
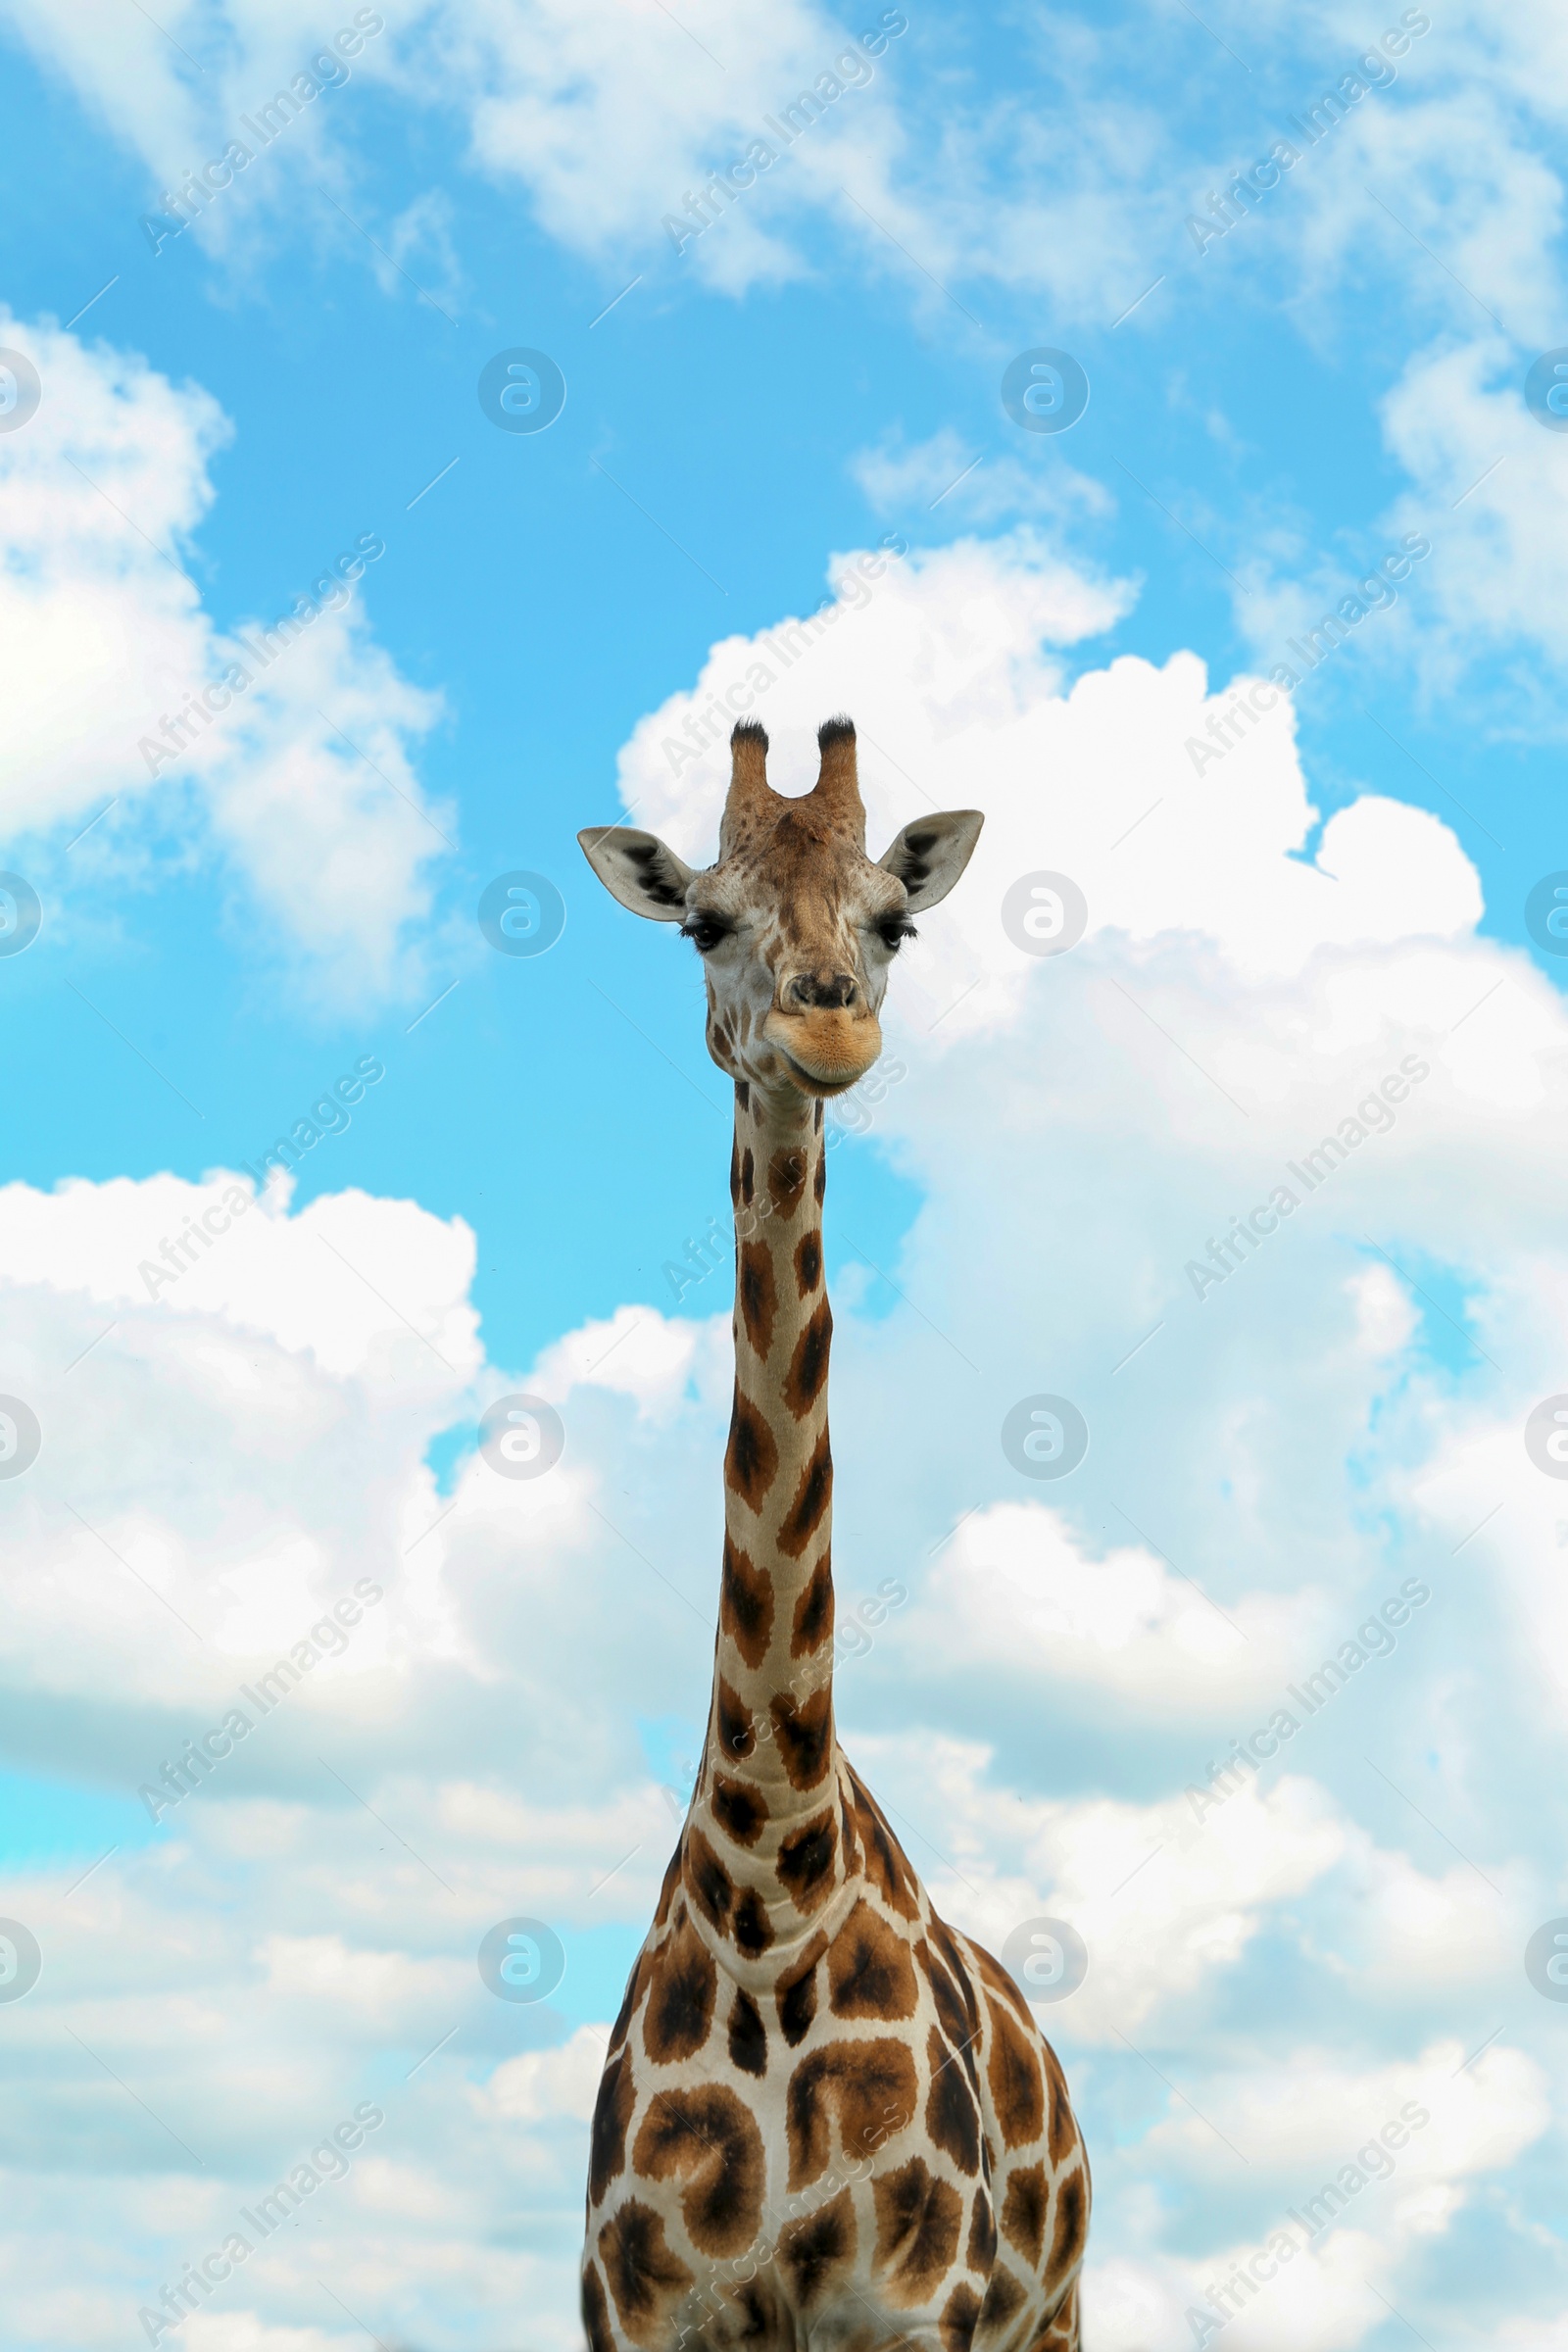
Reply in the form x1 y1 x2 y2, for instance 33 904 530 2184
578 717 1089 2352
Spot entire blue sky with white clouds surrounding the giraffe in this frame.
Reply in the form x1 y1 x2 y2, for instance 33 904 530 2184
0 0 1568 2352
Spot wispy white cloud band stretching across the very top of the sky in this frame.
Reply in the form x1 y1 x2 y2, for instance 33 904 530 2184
5 0 1568 341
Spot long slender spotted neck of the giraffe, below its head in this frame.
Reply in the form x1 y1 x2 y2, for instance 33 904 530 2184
686 1084 844 1974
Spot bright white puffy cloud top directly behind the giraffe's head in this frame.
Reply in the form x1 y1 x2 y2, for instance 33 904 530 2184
620 536 1481 1054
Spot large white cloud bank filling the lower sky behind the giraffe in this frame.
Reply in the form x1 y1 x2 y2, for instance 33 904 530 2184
0 519 1568 2352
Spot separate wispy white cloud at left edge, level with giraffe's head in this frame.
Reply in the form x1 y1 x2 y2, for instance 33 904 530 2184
0 318 452 1002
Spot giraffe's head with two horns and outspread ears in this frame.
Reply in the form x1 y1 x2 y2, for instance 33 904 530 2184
578 719 983 1096
